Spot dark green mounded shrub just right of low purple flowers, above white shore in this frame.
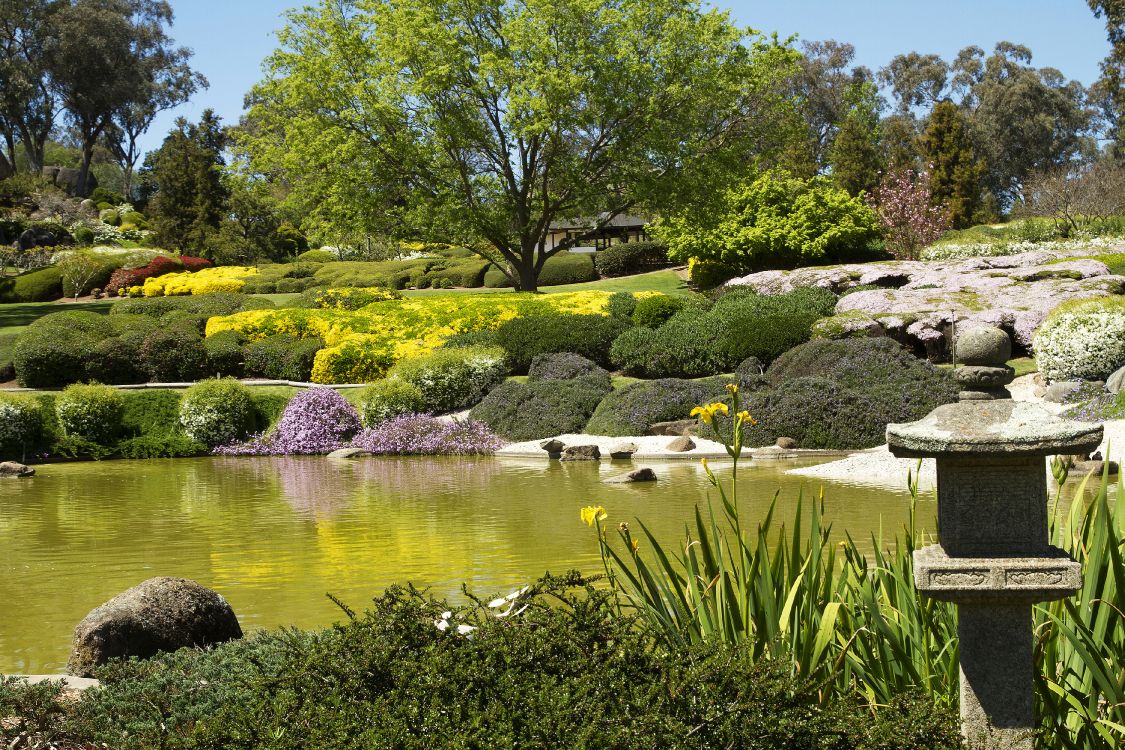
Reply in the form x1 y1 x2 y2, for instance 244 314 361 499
469 370 609 441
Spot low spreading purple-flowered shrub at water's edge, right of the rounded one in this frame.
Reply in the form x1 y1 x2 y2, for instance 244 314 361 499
351 414 504 455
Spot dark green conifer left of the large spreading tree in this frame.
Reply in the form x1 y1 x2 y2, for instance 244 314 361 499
145 109 230 253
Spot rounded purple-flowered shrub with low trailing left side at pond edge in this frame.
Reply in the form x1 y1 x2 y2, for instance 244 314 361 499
214 388 361 455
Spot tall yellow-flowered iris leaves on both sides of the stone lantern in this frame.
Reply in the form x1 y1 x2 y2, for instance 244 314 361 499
587 389 1125 749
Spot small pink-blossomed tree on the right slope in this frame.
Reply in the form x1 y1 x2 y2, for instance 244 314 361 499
867 169 950 261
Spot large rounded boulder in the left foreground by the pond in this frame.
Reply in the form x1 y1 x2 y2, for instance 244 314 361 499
66 577 242 677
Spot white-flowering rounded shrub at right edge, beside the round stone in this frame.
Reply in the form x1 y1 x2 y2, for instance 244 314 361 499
1034 297 1125 380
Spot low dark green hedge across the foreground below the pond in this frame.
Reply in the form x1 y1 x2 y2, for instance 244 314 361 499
0 575 961 750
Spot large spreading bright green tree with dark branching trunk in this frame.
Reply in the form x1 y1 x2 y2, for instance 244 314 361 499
241 0 797 291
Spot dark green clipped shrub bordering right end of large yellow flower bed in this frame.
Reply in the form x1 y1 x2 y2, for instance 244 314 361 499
496 315 629 373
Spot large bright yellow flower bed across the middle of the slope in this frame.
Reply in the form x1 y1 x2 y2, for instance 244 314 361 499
207 290 610 383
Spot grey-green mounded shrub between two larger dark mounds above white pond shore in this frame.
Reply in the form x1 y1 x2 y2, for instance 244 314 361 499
586 378 727 436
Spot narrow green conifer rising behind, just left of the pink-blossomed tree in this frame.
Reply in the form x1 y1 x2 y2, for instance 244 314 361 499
828 81 883 196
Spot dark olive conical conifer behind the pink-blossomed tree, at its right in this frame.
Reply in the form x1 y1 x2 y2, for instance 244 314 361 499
919 99 987 229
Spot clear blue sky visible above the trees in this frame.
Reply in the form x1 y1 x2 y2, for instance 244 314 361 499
143 0 1109 155
